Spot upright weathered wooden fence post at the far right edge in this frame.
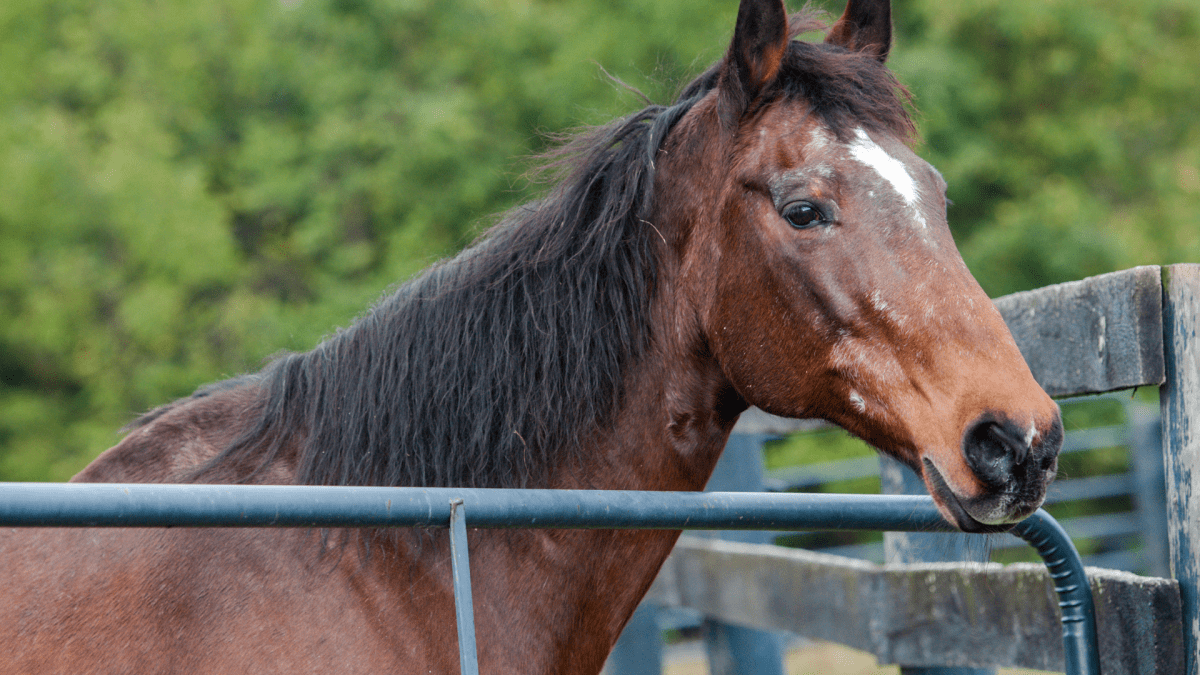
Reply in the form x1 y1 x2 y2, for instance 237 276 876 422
1160 264 1200 675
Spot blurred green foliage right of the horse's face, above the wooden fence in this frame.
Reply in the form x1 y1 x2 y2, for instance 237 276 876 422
893 0 1200 295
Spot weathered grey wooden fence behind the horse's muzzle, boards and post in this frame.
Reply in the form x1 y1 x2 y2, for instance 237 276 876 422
614 264 1200 675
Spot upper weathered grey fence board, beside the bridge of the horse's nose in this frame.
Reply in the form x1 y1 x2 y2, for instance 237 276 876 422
996 267 1166 396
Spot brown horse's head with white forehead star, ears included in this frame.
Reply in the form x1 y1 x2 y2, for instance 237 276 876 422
654 0 1062 531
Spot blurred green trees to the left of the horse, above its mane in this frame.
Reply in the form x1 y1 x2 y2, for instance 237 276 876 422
0 0 734 479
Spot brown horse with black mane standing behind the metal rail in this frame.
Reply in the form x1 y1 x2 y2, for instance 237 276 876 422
0 0 1062 674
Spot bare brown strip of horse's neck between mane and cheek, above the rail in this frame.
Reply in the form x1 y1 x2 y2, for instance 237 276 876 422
556 149 748 490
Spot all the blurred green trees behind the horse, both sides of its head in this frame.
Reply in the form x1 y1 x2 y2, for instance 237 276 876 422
0 0 1200 480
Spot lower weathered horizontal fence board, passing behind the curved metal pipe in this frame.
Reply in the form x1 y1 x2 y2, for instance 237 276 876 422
648 537 1183 675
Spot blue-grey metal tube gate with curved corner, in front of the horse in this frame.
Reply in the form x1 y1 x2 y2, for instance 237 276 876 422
0 483 1100 675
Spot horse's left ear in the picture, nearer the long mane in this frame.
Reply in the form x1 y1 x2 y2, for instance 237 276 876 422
719 0 788 124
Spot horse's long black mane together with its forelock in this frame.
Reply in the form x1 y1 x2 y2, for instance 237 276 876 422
192 9 911 488
